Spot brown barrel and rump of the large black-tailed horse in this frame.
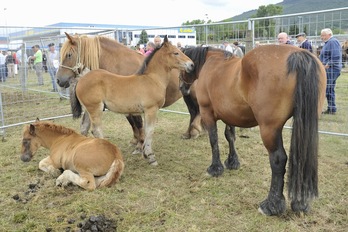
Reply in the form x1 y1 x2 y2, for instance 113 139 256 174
197 45 325 127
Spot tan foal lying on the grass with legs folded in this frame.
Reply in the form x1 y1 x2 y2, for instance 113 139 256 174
21 120 124 190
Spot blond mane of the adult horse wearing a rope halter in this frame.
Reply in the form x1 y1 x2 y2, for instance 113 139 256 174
61 35 100 70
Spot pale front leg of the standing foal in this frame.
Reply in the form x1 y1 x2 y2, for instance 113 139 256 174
143 108 158 165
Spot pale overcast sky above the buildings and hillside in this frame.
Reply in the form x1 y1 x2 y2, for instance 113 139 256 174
0 0 282 27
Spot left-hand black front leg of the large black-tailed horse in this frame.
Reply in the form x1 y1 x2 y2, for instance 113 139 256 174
207 121 224 177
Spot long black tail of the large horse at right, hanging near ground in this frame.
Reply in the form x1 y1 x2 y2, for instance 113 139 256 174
288 51 321 212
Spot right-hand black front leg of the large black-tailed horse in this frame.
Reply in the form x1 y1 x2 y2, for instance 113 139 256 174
225 125 240 169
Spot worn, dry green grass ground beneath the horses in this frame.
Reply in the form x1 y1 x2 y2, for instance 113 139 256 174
0 74 348 232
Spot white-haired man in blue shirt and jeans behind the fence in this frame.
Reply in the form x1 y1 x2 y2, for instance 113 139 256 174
319 28 342 114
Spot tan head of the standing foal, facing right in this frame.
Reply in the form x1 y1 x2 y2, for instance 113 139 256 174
158 36 194 73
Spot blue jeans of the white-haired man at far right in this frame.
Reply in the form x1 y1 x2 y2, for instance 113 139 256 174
326 68 341 112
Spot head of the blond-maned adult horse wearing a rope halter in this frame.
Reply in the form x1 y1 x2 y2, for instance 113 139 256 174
56 33 83 88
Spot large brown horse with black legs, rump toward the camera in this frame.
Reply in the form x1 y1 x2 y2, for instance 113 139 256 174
183 45 326 215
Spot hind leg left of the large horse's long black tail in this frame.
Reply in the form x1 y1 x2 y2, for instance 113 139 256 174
259 125 287 216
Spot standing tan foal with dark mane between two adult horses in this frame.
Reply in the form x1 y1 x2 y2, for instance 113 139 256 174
70 37 193 165
